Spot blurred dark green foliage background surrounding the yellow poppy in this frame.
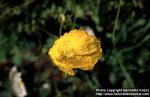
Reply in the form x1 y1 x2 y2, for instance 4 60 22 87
0 0 150 97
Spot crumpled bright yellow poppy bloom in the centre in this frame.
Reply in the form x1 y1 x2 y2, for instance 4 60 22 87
48 29 102 76
